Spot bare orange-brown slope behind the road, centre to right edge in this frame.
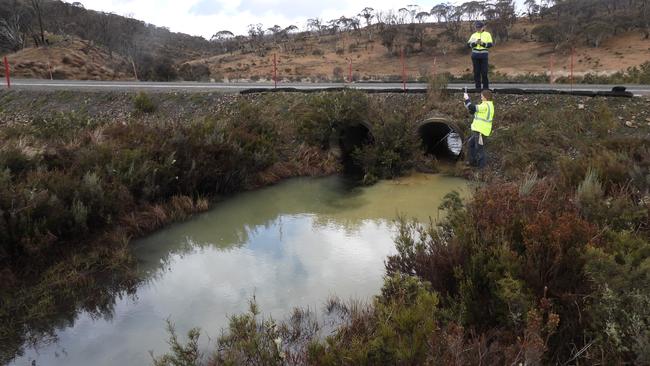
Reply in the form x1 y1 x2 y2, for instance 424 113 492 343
200 20 650 81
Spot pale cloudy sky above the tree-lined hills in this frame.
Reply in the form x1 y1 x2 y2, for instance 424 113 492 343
73 0 512 39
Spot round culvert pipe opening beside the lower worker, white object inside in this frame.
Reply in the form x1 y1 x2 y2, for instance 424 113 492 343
418 118 463 160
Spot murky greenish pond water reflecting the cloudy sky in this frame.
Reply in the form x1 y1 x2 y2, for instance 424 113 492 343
14 175 468 365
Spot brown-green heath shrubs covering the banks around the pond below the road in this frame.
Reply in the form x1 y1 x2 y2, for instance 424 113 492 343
0 88 650 365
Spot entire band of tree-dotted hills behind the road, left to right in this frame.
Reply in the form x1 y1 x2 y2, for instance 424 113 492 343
0 0 650 83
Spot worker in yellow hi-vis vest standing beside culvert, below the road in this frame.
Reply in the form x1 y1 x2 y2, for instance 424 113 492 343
463 89 494 168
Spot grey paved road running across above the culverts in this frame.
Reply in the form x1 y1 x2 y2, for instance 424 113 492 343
5 79 650 95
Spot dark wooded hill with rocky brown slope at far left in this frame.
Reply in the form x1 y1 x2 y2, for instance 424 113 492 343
0 0 214 81
